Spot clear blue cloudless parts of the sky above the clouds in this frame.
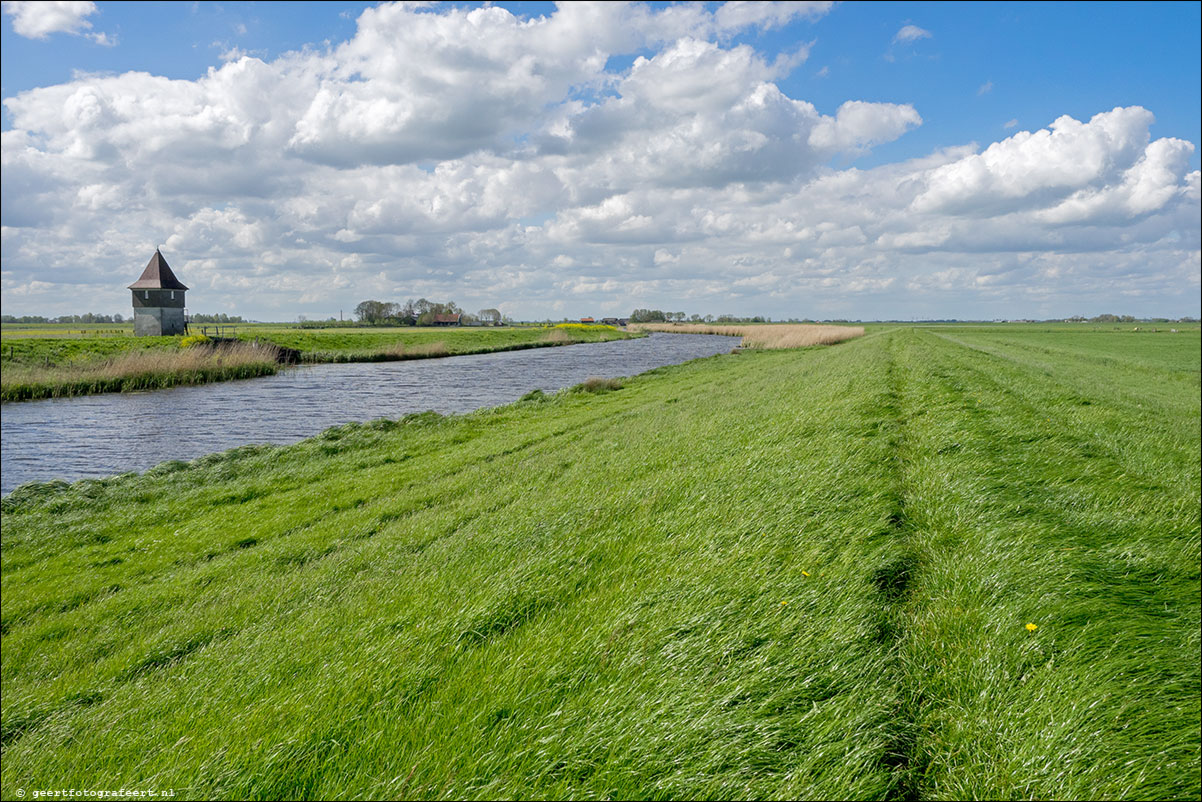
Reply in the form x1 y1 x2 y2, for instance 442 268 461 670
7 1 1202 168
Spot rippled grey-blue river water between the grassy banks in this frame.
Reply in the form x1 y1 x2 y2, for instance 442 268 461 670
0 334 738 493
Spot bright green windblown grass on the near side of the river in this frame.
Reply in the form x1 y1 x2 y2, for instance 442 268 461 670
0 329 1202 800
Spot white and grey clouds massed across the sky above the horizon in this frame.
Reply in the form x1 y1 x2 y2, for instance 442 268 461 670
2 2 1202 319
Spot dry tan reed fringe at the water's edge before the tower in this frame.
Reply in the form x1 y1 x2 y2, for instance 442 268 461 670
0 343 279 402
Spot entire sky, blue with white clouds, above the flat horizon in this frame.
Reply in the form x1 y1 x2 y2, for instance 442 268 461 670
0 2 1202 319
